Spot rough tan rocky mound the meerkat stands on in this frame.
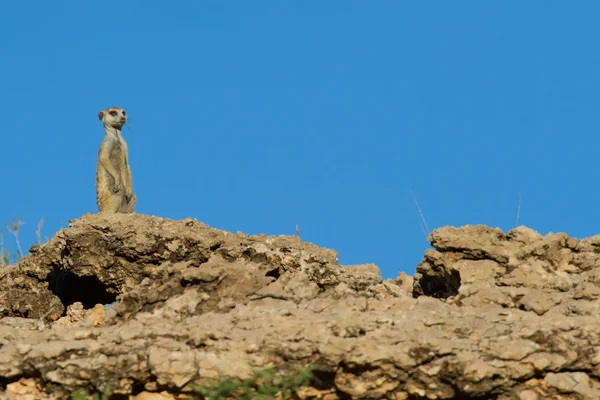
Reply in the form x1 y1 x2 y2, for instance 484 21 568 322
0 214 600 400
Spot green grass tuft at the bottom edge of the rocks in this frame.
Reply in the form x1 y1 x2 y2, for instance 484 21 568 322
192 366 313 400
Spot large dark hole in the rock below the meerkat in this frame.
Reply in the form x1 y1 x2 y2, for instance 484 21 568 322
48 271 117 309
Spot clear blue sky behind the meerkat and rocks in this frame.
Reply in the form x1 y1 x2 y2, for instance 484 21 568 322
0 0 600 278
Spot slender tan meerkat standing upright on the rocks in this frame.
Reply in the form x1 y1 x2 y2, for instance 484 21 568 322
96 107 136 213
